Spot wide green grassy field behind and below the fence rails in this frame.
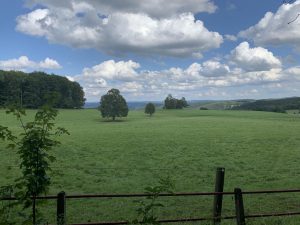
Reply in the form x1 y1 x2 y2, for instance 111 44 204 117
0 109 300 224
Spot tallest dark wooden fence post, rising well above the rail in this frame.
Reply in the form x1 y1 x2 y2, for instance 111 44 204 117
213 167 225 225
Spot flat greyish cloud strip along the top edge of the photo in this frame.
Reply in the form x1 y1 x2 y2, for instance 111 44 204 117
27 0 217 18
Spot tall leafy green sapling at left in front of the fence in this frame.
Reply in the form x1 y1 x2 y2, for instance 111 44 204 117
0 107 69 224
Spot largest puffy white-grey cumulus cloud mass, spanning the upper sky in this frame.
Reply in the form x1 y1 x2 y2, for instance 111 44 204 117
16 0 223 57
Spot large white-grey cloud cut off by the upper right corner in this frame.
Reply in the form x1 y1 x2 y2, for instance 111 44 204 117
239 0 300 50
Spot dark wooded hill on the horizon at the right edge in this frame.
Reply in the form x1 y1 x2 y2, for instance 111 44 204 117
232 97 300 112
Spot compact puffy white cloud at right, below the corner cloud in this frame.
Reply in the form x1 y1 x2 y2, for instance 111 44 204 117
230 42 281 71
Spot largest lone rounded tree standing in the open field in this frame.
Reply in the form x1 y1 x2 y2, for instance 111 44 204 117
99 88 128 121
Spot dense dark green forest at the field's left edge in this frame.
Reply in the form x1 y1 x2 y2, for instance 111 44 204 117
0 70 85 108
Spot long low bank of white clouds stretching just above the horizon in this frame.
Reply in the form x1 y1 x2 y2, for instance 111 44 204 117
73 59 292 99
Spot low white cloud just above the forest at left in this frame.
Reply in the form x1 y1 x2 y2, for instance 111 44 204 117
0 56 62 71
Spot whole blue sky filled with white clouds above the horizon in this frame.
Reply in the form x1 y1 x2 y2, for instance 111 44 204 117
0 0 300 102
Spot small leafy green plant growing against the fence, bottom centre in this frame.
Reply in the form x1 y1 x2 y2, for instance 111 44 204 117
132 177 174 225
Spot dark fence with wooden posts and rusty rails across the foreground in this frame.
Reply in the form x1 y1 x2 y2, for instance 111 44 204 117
0 168 300 225
